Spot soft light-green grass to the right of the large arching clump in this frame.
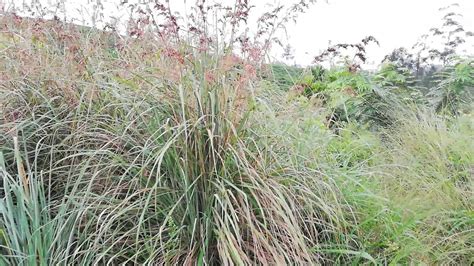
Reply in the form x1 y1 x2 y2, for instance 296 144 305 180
255 79 474 264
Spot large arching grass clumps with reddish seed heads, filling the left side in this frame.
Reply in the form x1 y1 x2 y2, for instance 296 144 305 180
0 1 360 265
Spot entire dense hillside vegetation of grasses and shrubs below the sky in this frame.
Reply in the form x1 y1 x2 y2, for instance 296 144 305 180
0 1 474 265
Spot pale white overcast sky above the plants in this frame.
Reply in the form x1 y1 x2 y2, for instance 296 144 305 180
4 0 474 65
